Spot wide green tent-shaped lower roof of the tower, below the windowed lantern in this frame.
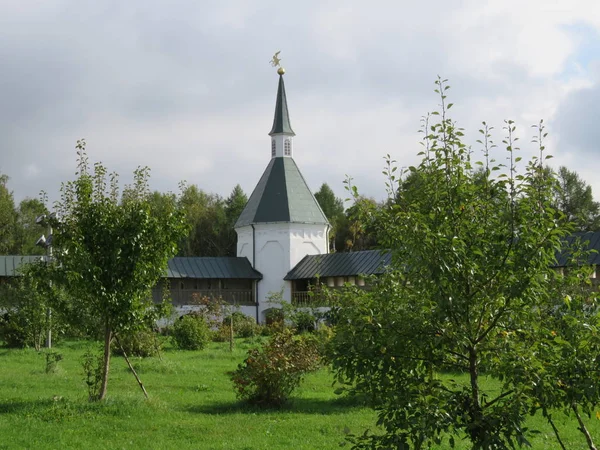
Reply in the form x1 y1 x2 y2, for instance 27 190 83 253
235 157 329 228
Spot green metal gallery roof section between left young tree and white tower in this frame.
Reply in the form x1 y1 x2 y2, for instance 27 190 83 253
167 256 262 280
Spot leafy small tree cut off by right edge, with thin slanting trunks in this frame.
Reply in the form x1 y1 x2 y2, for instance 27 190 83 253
510 234 600 450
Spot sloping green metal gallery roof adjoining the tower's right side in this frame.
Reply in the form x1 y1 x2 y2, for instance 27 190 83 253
284 250 392 280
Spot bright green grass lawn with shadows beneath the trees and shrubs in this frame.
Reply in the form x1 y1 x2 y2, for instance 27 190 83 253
0 341 600 449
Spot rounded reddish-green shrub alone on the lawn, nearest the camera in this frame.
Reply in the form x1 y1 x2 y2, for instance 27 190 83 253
231 329 320 406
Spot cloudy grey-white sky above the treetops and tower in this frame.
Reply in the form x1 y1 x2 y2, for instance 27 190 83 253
0 0 600 206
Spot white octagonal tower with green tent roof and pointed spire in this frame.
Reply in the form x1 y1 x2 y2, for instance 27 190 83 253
235 67 329 322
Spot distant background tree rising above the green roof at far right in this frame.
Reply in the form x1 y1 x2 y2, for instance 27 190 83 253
554 166 600 231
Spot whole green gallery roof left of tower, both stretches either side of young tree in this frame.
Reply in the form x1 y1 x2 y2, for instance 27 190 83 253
0 256 262 280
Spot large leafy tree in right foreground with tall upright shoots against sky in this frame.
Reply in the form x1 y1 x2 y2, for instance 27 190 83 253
332 80 568 449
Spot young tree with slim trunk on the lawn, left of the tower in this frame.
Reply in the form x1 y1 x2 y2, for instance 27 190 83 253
53 140 185 400
